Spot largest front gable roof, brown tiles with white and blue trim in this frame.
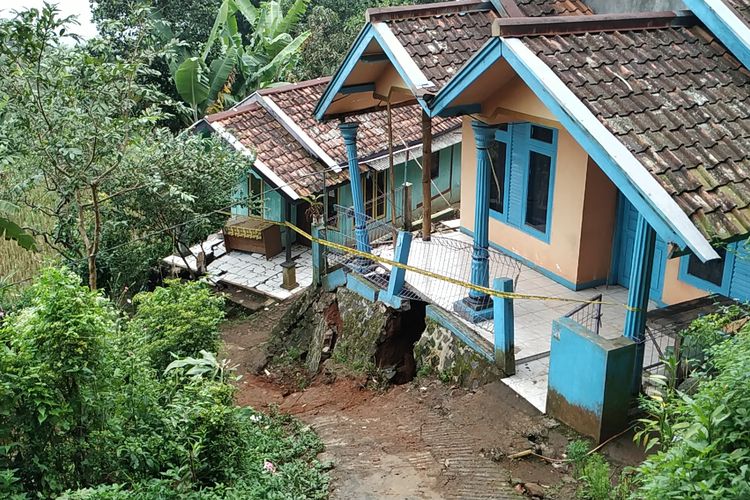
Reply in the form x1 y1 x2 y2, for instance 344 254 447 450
432 13 750 260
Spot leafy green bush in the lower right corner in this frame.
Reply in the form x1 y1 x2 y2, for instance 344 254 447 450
637 318 750 499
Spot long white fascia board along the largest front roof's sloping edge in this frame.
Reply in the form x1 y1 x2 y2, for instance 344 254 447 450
502 38 719 262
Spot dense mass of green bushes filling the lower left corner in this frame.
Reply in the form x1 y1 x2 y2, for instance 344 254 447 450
0 269 327 499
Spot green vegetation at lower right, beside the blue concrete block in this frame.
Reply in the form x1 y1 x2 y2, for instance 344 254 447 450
635 307 750 499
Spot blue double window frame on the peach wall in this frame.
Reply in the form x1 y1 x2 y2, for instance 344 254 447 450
490 123 557 242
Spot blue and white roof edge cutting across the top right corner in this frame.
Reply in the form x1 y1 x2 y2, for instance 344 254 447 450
684 0 750 68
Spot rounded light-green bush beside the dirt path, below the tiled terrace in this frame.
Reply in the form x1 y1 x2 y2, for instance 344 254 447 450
128 280 224 370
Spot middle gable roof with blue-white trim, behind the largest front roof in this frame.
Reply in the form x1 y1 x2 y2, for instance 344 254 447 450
315 0 591 120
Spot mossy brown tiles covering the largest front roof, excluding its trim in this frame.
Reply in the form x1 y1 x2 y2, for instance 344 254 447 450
522 26 750 239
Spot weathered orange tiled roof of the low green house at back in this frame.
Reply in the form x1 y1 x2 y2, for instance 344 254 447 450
204 78 461 200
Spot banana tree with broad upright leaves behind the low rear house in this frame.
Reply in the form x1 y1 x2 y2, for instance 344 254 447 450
170 0 310 120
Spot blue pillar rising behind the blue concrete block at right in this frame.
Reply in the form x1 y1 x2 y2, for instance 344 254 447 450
623 214 656 394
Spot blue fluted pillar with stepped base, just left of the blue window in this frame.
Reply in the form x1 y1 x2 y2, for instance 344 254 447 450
455 120 495 323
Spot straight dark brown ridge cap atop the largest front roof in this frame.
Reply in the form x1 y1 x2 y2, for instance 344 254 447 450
492 11 698 37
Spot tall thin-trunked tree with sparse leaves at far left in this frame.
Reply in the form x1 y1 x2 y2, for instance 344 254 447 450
0 6 248 289
